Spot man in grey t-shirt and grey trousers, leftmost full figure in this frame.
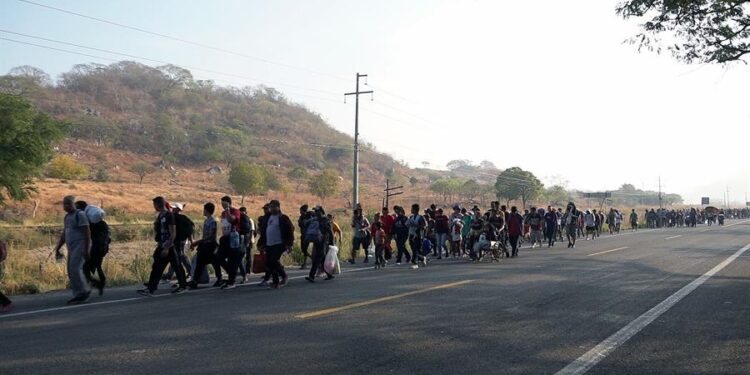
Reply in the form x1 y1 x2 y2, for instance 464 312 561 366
54 195 91 305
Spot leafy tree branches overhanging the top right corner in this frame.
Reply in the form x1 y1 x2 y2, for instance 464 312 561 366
616 0 750 64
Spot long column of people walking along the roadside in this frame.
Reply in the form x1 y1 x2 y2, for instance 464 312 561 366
0 196 750 312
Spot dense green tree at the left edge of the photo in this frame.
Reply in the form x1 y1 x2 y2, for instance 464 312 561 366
0 94 65 204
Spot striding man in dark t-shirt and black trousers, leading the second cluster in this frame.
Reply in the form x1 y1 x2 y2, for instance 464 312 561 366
137 197 187 297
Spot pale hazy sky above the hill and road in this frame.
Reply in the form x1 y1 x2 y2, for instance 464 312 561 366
0 0 750 204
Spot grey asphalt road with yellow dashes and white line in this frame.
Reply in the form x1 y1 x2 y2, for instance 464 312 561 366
0 221 750 375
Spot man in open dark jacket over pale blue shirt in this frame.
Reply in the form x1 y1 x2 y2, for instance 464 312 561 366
258 200 294 289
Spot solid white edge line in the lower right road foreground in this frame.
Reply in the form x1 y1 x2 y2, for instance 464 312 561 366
557 244 750 375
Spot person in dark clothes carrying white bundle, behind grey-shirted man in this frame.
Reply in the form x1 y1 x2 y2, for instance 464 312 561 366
75 201 111 296
